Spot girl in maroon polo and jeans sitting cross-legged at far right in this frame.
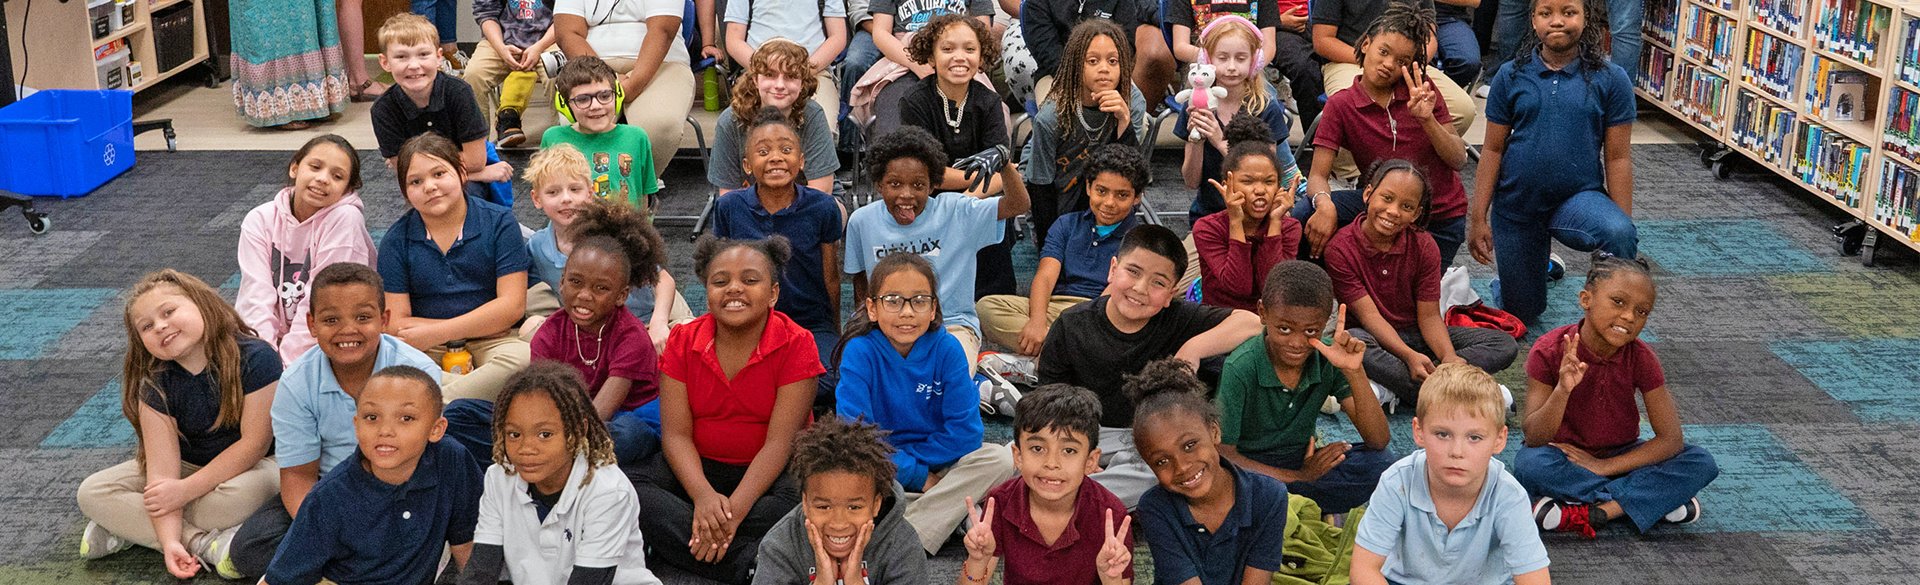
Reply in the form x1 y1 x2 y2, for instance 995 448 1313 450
1513 255 1720 539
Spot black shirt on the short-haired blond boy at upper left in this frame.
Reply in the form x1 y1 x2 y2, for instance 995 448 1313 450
372 71 488 159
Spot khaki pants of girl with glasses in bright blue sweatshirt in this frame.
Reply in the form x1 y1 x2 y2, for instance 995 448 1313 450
902 443 1020 554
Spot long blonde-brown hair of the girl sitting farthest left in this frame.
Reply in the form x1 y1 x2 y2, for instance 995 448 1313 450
121 269 255 470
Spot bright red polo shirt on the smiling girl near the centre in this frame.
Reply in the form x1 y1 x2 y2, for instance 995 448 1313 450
660 311 826 466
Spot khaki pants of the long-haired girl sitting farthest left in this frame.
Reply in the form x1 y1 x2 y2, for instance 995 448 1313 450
75 456 280 550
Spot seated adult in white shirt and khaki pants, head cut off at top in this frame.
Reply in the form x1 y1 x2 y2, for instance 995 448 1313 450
553 0 693 176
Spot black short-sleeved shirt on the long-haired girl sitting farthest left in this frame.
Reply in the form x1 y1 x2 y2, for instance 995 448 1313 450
140 338 280 466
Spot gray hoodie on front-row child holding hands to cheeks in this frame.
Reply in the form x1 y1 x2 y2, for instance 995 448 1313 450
753 483 927 585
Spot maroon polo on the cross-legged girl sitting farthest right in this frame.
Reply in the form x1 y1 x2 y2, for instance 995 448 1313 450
1526 318 1667 450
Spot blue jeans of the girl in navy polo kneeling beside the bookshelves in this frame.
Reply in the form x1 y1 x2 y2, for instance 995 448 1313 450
1488 192 1640 324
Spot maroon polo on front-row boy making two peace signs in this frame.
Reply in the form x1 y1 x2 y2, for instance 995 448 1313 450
987 478 1133 585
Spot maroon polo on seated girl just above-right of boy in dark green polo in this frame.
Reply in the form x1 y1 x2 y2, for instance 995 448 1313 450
1325 213 1440 330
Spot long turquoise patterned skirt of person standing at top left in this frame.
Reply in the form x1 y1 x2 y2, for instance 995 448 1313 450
230 0 353 130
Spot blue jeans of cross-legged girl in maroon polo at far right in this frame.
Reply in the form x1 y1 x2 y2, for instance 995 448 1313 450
1513 441 1720 533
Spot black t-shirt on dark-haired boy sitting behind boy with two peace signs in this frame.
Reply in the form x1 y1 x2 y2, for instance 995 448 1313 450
1039 295 1233 428
